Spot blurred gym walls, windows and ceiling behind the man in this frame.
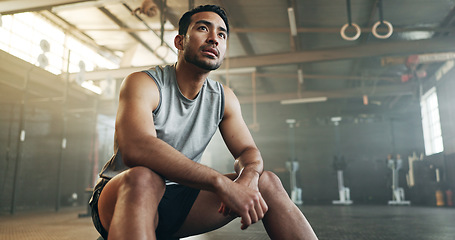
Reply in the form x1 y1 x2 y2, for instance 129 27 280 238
0 0 455 214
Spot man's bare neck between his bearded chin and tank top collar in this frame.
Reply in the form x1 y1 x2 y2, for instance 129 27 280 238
175 61 210 99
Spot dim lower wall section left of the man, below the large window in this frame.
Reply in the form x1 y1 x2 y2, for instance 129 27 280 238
0 103 112 212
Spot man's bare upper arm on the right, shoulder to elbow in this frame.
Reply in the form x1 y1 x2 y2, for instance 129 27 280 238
220 88 256 158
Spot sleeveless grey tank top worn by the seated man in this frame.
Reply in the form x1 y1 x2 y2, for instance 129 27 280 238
100 65 224 184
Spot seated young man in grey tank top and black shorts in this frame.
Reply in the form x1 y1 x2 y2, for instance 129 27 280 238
90 5 317 239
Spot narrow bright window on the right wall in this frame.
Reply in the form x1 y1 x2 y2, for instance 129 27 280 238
420 87 444 156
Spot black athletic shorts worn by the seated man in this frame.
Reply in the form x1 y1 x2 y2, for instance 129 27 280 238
89 179 199 240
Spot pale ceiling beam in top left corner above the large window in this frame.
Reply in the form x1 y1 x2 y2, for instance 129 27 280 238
0 0 94 15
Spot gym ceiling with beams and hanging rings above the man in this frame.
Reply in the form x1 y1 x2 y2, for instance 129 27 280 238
0 0 455 117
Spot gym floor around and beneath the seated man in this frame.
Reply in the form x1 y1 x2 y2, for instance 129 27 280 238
0 205 455 240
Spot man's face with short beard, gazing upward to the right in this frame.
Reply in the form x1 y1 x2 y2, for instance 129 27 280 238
183 12 227 71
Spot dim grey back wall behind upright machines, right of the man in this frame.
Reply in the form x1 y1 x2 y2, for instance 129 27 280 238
208 96 424 204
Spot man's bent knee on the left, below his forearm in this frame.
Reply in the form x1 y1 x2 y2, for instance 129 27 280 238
122 167 165 193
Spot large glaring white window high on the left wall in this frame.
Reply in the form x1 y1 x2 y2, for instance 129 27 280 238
0 13 119 75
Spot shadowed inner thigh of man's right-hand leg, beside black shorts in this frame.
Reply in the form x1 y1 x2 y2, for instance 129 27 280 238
175 174 237 237
